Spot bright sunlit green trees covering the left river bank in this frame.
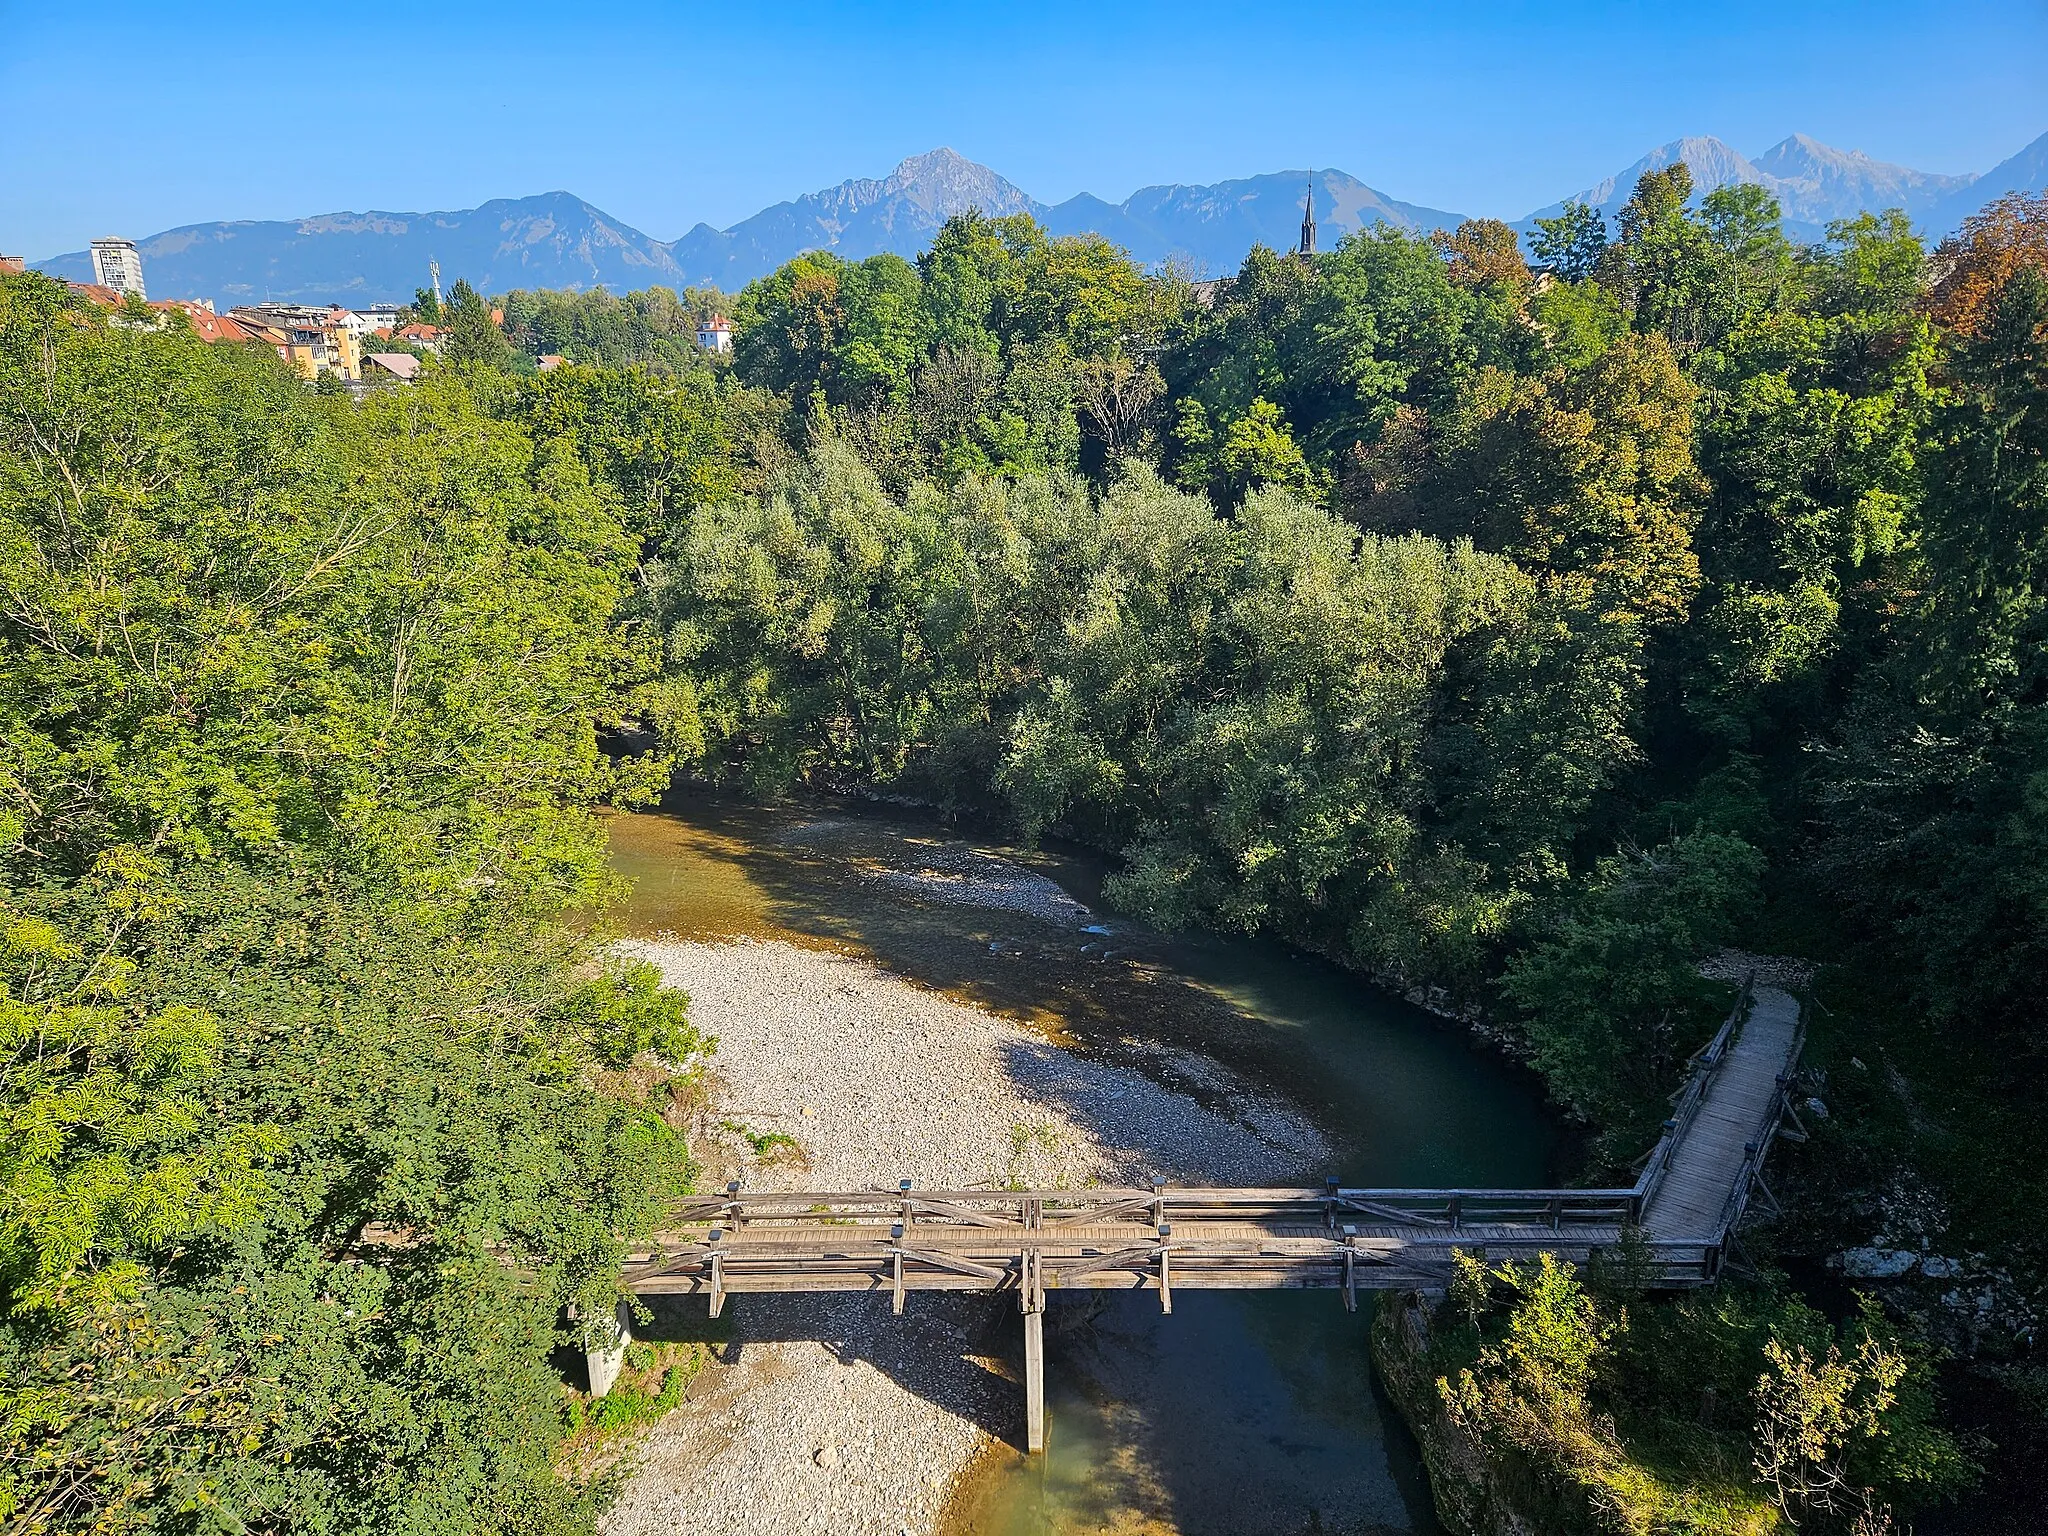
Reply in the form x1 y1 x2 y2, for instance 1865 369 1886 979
0 274 696 1532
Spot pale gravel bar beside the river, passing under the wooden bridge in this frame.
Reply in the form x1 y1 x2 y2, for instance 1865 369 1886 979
606 933 1329 1536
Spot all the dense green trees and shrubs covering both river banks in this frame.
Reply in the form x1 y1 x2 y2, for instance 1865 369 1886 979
0 166 2048 1532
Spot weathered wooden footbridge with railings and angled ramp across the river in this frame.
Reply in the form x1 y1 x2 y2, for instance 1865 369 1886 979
590 981 1804 1450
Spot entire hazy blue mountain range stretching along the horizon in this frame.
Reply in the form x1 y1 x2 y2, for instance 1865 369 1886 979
37 133 2048 305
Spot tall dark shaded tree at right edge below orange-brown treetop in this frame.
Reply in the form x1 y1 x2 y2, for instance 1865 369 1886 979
1827 268 2048 1042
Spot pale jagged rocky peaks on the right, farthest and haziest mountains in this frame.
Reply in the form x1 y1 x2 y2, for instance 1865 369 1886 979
1516 133 1978 240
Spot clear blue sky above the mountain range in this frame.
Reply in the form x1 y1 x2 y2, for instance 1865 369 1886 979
0 0 2048 258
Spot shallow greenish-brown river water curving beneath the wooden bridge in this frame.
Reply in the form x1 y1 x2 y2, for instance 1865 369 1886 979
612 795 1561 1536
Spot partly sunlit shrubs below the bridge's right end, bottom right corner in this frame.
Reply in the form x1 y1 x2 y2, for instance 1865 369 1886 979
1432 1253 1970 1536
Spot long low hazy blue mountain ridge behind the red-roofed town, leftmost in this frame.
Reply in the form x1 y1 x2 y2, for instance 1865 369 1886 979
37 193 680 307
